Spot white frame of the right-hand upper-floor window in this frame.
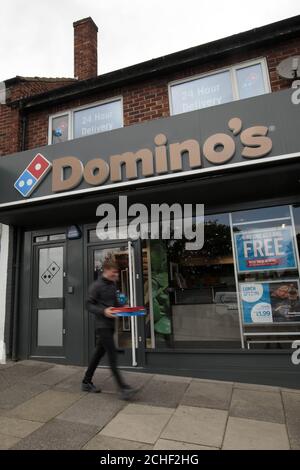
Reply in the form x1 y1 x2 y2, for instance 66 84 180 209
168 57 271 116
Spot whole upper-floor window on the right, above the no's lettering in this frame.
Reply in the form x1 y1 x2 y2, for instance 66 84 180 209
169 59 270 114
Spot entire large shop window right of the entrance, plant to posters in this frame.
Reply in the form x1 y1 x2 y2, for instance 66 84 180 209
143 206 300 349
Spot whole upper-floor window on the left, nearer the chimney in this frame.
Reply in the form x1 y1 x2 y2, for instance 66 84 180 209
49 98 123 144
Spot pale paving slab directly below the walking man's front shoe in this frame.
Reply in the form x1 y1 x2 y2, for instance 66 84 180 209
100 404 173 444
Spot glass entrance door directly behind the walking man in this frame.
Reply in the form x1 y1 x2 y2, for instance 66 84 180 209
89 242 137 366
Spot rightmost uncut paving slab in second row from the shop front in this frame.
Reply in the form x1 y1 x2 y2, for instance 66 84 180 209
229 389 285 424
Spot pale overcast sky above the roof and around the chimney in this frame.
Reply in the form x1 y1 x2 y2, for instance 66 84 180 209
0 0 300 81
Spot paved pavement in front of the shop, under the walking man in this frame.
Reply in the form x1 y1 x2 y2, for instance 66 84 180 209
0 360 300 450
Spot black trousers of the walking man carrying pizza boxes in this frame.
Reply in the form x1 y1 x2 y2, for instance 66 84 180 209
83 328 126 388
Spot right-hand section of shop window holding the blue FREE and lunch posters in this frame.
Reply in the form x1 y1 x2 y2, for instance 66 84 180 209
232 206 300 348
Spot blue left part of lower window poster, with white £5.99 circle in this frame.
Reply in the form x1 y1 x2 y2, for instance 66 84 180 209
240 283 273 323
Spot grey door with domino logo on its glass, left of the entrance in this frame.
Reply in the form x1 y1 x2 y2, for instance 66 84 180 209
31 244 65 357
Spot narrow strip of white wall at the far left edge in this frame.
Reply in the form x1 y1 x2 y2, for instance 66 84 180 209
0 225 9 364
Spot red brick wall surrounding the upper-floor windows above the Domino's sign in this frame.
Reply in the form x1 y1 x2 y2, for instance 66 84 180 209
0 38 300 153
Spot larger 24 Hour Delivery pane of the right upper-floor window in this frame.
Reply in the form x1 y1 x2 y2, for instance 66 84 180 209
171 71 233 114
